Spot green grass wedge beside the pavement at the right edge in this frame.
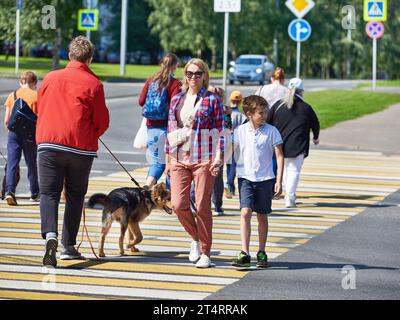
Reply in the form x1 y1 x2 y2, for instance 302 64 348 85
304 90 400 129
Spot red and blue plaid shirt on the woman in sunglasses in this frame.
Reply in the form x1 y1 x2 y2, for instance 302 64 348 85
166 88 225 162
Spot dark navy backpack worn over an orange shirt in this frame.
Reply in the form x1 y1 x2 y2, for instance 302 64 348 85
7 91 37 141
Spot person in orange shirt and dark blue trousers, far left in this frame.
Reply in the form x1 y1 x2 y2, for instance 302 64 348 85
4 71 39 206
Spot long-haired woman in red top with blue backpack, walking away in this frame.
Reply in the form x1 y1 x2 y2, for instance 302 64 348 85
139 53 182 188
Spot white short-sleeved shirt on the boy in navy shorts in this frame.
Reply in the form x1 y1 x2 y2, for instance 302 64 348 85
233 122 283 182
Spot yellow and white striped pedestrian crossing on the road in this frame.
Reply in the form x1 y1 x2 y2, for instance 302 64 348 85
0 150 400 299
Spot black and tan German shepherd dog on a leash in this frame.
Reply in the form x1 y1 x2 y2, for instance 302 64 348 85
88 182 172 257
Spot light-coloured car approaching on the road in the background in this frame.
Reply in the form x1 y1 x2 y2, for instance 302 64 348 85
229 54 274 85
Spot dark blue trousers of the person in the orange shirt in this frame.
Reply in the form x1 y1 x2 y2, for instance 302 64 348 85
6 131 39 195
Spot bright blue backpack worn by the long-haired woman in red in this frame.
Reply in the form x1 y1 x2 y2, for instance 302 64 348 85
143 80 169 120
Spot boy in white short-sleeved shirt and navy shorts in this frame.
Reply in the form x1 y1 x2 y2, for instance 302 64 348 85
232 95 284 268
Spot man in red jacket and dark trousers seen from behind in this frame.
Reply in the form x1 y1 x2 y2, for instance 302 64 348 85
36 36 110 267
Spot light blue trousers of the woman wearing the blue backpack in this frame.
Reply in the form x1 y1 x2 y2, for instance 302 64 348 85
147 127 167 181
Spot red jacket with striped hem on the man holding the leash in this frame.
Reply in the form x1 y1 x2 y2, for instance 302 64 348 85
36 61 110 156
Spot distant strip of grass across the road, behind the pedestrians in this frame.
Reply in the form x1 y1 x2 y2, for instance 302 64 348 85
0 55 222 80
